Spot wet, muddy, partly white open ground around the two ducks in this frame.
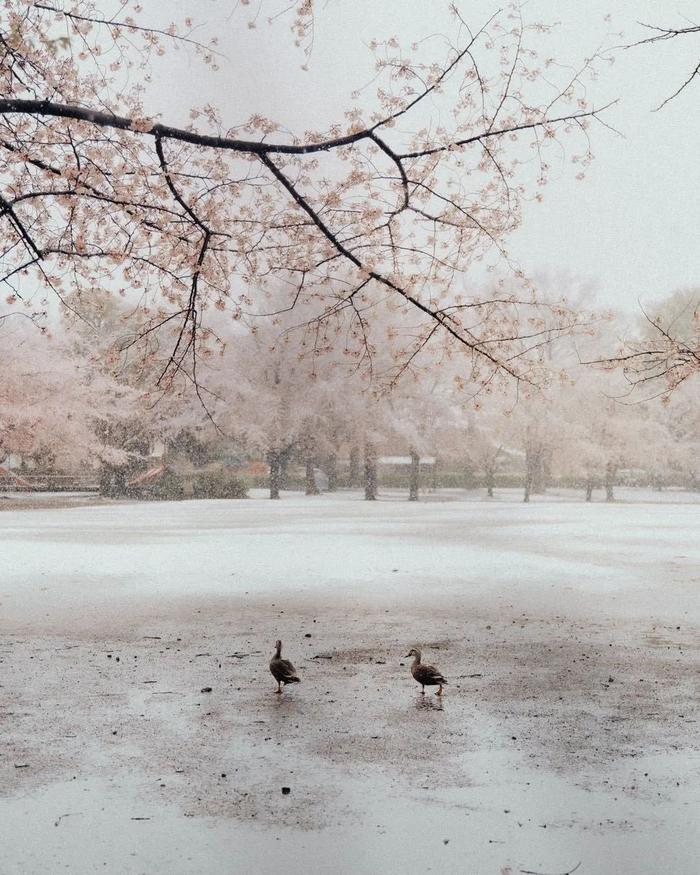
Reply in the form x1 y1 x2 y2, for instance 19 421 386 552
0 490 700 875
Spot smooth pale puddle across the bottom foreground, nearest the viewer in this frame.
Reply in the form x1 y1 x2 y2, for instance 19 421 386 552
0 751 700 875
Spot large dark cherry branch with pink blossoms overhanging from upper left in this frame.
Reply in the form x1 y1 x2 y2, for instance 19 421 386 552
0 0 604 405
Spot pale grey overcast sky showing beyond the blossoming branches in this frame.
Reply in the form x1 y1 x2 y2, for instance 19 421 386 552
149 0 700 310
